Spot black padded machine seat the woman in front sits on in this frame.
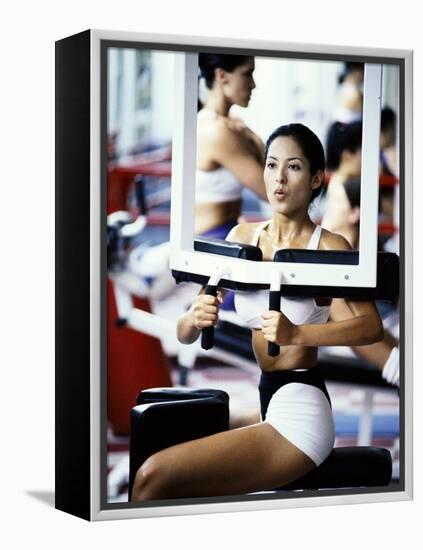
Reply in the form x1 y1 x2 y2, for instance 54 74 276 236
129 388 392 502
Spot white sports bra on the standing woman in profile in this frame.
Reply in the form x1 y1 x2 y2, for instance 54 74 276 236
195 166 243 203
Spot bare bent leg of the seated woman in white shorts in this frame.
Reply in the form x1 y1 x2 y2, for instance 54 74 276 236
132 422 315 501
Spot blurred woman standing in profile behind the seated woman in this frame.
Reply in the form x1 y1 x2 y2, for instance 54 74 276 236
195 54 267 239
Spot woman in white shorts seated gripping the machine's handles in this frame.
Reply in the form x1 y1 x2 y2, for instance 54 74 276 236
132 124 383 501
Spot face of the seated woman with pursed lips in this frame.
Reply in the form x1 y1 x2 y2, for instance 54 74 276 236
264 136 323 216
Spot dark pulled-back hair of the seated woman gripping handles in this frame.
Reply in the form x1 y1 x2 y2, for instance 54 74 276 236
264 123 325 202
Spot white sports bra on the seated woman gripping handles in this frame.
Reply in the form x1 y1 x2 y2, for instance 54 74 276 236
235 220 330 329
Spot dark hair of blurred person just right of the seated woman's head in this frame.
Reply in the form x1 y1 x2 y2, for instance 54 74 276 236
326 121 363 170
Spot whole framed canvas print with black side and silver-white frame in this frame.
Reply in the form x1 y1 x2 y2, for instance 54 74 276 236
56 30 412 520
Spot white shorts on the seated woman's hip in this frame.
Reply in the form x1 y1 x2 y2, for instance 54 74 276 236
265 382 335 466
